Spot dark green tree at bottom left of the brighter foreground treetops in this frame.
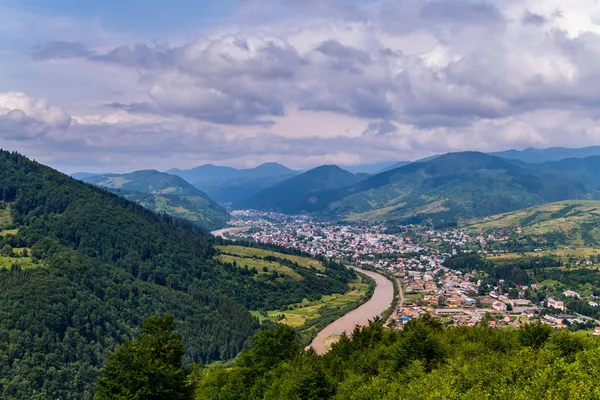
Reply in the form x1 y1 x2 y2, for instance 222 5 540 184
94 315 191 400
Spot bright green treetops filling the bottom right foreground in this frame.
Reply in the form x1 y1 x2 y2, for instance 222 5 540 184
192 317 600 400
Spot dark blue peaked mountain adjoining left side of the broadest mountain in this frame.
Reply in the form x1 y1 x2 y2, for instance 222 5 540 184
237 165 362 214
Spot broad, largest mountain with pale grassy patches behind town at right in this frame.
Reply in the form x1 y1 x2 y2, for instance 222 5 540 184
322 152 597 223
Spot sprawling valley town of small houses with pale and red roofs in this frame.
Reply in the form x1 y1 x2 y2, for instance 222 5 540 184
228 210 600 335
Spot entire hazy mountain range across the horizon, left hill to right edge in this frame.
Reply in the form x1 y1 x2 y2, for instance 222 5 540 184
76 146 600 228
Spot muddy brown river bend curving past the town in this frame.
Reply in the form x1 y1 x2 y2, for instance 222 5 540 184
310 268 394 354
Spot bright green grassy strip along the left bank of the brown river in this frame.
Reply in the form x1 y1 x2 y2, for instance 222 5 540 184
252 278 369 328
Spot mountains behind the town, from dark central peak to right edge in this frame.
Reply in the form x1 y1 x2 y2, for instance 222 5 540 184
240 152 600 223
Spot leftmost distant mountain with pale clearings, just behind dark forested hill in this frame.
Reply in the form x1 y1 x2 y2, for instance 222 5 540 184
83 170 228 230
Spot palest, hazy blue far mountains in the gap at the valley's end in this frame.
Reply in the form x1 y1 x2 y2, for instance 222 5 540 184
169 162 299 203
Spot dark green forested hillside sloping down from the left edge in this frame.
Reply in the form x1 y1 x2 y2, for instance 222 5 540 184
0 151 353 399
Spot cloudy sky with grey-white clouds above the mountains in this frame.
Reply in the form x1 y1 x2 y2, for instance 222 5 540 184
0 0 600 173
